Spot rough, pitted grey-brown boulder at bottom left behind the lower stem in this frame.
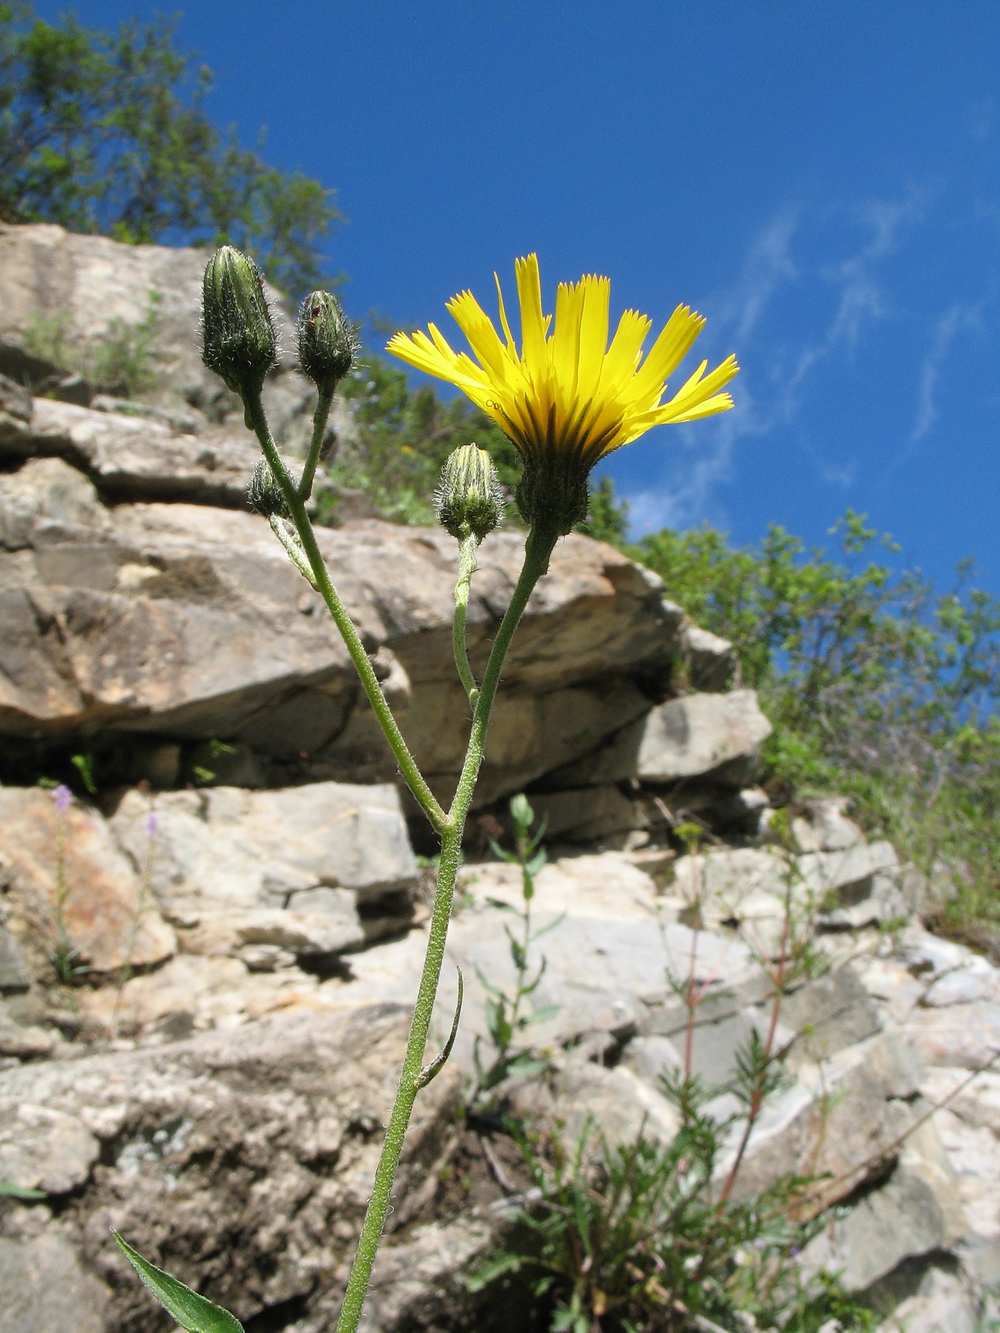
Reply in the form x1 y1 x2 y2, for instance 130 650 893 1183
0 1006 459 1333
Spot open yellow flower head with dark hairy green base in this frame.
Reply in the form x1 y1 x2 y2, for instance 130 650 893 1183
388 255 739 532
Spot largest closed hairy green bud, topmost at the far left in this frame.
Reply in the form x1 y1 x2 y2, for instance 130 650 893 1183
201 245 277 399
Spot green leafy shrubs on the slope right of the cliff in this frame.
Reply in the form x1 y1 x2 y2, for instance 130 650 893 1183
628 512 1000 916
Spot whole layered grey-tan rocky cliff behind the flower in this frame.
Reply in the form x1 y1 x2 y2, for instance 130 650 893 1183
0 227 1000 1333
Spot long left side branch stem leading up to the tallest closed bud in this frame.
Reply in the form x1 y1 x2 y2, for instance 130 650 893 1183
244 395 448 833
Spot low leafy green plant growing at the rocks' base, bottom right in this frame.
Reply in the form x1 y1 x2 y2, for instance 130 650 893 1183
469 1082 876 1333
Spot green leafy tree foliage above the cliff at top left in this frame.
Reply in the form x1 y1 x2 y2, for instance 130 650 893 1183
0 0 339 295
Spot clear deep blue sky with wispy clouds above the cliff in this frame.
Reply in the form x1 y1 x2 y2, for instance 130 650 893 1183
36 0 1000 592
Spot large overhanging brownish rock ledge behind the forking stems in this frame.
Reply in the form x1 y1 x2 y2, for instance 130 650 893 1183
0 501 680 804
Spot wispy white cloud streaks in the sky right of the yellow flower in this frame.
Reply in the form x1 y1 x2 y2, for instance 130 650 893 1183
620 188 1000 532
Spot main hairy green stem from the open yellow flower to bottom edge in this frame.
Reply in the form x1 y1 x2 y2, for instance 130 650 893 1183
336 528 559 1333
